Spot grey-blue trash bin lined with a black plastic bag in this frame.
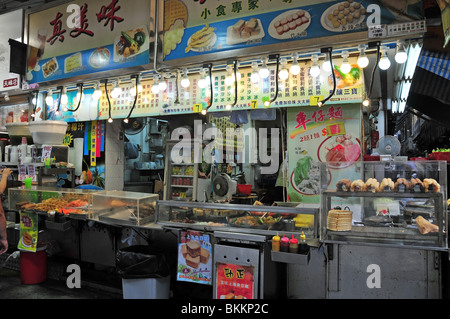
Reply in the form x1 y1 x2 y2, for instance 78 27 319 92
116 245 170 299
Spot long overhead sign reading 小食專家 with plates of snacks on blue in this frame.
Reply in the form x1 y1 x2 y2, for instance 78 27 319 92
163 0 424 61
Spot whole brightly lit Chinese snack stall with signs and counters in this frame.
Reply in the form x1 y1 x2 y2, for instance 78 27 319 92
0 0 447 299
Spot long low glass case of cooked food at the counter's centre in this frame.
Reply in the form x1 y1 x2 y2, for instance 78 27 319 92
156 201 319 238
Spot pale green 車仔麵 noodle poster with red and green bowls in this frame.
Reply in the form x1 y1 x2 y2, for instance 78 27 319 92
287 104 363 204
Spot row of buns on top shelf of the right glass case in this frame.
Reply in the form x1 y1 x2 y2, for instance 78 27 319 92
336 178 441 193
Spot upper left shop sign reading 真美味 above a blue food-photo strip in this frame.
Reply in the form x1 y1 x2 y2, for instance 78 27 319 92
27 0 151 83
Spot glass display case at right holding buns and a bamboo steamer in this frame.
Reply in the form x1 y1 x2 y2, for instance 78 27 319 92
320 161 447 250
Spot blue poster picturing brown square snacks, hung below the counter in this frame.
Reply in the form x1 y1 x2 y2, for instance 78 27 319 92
177 231 212 285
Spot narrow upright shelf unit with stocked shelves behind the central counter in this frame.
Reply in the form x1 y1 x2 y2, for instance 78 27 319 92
164 141 198 201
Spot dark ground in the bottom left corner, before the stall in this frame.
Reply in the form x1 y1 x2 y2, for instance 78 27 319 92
0 268 123 299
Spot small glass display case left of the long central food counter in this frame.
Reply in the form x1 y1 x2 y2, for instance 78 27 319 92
92 190 159 226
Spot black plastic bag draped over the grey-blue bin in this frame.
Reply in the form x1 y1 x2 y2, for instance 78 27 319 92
116 245 170 279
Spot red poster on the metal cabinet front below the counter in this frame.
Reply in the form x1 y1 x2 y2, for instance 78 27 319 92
216 263 254 299
